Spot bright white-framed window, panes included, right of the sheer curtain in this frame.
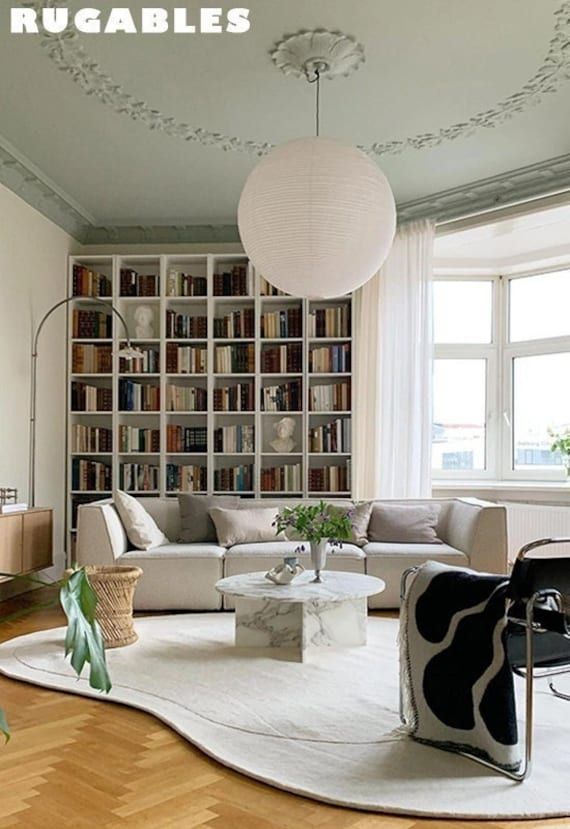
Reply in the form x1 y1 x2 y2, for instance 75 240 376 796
432 269 570 480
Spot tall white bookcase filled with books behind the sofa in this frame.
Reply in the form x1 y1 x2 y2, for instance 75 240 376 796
68 253 355 544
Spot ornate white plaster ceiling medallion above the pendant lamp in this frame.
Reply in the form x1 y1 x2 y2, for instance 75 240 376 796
271 29 365 79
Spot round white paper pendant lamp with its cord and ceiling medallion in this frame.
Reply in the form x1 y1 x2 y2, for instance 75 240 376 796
238 31 396 298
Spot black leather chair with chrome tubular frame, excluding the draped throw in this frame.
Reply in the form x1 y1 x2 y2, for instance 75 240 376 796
401 538 570 782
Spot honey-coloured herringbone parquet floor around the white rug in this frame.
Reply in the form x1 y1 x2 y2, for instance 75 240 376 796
0 600 570 829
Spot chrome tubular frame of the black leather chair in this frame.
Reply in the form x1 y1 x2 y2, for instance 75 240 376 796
400 538 570 783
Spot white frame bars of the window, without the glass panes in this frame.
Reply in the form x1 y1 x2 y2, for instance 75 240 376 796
432 262 570 486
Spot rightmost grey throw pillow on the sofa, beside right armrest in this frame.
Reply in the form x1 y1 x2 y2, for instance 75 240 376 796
368 504 441 544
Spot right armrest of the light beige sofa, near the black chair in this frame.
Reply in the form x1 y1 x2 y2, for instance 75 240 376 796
442 498 508 574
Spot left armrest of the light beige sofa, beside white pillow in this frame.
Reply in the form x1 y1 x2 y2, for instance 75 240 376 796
76 501 129 565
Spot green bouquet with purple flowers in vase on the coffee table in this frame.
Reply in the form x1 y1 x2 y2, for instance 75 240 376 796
273 501 352 583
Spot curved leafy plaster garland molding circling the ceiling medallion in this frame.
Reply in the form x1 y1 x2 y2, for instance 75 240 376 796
24 0 570 157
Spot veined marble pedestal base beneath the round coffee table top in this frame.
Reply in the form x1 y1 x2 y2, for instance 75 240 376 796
236 598 367 662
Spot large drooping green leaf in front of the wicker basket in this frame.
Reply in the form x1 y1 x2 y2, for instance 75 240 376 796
60 570 111 693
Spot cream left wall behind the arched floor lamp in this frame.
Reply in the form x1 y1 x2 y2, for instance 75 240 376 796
0 186 75 595
